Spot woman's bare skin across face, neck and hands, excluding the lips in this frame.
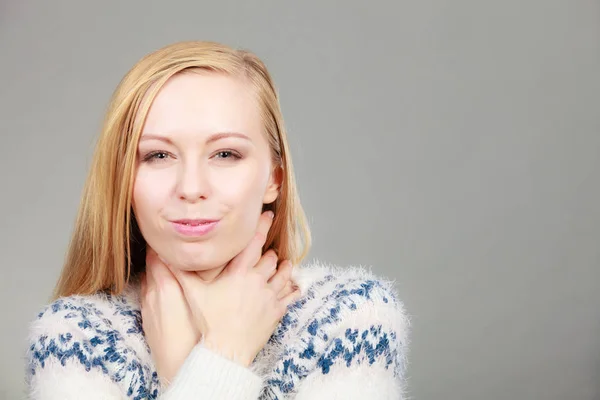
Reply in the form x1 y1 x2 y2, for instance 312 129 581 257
133 73 299 385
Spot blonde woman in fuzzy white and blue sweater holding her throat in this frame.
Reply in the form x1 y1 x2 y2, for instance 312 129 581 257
27 42 407 400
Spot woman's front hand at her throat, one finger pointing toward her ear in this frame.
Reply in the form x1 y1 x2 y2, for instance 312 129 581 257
171 211 300 366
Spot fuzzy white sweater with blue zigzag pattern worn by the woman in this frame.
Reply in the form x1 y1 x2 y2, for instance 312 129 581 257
27 263 408 400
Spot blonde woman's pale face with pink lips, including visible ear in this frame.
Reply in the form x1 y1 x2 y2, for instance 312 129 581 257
133 72 280 271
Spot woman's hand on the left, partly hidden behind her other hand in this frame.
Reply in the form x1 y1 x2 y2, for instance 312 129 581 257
141 248 200 386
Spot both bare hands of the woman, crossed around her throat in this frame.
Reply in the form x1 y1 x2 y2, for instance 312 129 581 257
141 213 300 385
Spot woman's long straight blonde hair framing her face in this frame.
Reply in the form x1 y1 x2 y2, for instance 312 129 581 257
54 41 311 298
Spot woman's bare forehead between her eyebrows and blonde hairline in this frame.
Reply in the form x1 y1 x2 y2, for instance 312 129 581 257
144 71 263 136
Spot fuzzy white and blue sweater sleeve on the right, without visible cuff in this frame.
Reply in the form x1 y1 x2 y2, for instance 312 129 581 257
286 280 409 400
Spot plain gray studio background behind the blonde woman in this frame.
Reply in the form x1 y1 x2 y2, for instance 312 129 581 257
0 0 600 400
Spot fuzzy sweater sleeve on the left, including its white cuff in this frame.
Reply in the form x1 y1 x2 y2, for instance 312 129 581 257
26 299 262 400
